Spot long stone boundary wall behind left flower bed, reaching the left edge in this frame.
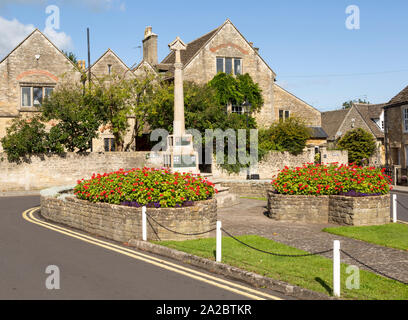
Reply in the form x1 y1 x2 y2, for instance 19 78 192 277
0 152 161 192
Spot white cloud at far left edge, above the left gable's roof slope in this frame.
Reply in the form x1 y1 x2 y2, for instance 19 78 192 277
0 17 35 58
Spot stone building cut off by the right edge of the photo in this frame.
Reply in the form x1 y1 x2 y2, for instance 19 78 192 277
384 87 408 169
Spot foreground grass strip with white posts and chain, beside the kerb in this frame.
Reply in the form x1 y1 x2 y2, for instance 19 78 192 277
155 235 408 300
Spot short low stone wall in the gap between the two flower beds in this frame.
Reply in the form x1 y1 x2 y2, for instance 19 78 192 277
220 180 271 198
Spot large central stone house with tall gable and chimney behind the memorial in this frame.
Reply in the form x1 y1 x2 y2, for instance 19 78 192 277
134 20 321 132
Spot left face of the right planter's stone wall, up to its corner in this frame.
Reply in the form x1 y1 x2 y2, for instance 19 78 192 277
268 190 329 224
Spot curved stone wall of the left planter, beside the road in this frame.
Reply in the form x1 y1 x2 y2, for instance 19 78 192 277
41 186 217 242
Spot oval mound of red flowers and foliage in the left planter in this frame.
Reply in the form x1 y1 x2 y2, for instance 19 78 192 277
74 168 217 208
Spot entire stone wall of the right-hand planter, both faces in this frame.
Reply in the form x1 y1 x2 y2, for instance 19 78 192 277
268 190 391 226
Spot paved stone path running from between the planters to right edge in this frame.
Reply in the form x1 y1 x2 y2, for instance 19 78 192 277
218 199 408 282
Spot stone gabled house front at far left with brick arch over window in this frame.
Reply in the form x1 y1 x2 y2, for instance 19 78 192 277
0 29 81 151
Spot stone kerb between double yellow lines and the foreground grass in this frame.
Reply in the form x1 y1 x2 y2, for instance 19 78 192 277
129 239 338 300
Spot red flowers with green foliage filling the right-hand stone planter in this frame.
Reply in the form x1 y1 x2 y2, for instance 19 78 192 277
272 164 391 196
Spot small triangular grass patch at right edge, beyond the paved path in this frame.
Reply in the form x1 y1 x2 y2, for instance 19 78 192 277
323 223 408 250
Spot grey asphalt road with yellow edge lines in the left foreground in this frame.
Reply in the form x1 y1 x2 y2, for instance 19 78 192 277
0 196 285 300
